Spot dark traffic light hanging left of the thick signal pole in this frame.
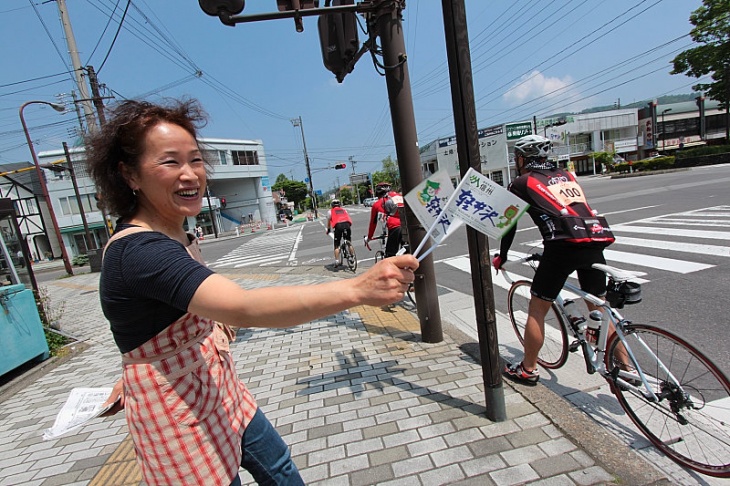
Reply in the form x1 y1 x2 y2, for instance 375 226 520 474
317 0 360 83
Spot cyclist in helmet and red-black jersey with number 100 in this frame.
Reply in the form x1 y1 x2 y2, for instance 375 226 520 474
492 135 614 385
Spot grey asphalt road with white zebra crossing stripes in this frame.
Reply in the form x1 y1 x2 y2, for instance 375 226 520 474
198 165 730 370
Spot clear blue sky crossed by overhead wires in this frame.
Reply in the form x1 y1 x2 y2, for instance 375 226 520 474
0 0 701 191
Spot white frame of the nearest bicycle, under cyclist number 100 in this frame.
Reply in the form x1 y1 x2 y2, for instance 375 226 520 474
502 255 686 402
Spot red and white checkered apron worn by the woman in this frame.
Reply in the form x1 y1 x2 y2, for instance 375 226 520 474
109 228 256 486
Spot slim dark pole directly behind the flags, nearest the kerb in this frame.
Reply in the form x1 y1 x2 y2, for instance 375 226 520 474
441 0 507 422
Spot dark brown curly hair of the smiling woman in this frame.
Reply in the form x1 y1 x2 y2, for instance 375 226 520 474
86 99 207 219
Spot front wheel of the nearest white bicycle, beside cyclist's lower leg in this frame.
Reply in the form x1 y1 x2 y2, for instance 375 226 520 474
507 280 568 369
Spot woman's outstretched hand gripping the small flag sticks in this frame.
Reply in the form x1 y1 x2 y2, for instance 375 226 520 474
352 255 418 306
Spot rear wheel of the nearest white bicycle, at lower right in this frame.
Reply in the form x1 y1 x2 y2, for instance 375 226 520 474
607 324 730 478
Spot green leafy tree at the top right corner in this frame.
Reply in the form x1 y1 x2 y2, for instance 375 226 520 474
672 0 730 138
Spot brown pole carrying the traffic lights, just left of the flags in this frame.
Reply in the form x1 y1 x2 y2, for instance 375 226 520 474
375 1 443 343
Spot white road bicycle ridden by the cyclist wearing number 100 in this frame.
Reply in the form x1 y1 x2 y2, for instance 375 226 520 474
502 253 730 478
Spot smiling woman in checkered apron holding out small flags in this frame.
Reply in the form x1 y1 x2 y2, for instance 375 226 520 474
82 101 418 485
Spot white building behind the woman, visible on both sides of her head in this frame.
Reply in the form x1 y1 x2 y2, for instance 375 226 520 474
28 138 276 258
